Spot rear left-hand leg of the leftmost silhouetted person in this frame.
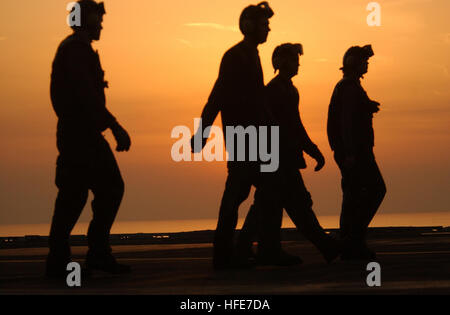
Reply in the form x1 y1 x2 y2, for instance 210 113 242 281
46 158 88 276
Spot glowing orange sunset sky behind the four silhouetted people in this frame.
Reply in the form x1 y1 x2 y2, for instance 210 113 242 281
0 0 450 228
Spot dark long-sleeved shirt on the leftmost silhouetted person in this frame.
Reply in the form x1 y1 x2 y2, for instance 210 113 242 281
50 34 116 151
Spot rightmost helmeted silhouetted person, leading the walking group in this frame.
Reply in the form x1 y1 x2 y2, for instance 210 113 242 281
327 45 386 260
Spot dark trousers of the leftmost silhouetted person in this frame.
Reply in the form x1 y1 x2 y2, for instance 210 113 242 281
49 137 124 259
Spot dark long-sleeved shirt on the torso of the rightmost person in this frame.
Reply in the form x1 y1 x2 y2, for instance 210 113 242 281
327 77 375 155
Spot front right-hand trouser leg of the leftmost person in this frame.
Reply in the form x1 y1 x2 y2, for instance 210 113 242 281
88 141 124 256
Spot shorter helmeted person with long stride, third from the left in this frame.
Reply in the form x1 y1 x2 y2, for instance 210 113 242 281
237 43 339 266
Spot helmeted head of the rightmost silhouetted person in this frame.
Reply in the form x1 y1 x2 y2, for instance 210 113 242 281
341 45 374 78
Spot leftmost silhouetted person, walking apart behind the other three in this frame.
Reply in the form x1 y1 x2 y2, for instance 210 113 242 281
46 0 131 277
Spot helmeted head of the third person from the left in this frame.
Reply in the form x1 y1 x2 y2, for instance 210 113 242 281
272 43 303 78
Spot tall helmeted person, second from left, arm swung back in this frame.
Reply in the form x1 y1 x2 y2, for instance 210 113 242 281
191 2 274 270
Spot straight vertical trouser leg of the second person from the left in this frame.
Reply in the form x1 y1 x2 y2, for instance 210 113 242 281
213 169 252 268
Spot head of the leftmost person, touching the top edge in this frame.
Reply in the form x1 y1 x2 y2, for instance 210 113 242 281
72 0 106 40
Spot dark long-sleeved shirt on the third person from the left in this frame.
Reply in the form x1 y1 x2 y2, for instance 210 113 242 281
266 75 320 168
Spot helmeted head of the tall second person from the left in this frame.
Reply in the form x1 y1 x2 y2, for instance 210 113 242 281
239 1 274 44
